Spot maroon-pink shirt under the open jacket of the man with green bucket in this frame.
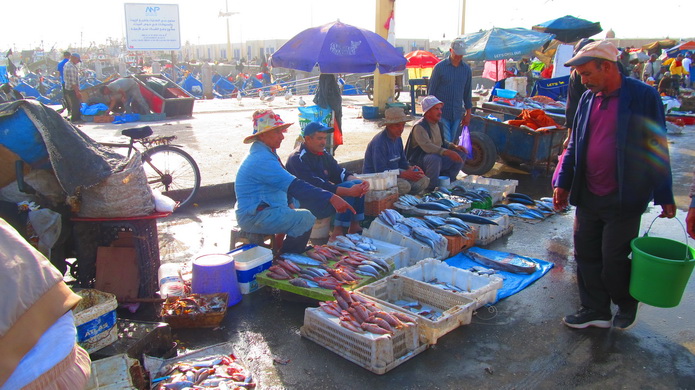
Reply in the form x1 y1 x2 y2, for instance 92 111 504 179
586 93 618 196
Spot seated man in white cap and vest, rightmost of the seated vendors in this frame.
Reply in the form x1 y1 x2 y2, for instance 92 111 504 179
405 96 467 190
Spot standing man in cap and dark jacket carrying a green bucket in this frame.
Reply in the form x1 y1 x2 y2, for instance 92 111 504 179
553 41 676 330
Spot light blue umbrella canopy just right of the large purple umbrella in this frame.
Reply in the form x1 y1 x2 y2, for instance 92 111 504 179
461 27 554 61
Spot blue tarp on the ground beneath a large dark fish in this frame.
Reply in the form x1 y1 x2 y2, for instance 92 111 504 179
445 247 553 303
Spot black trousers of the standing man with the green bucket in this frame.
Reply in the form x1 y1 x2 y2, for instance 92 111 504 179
574 189 642 315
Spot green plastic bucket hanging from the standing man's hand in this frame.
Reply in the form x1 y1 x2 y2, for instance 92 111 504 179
630 221 695 307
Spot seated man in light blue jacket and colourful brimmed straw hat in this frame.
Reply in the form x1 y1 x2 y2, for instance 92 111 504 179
234 110 355 253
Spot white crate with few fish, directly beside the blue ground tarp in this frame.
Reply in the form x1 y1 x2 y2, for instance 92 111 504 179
394 259 503 309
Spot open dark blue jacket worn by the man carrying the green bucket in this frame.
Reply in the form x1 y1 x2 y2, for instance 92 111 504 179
556 76 674 213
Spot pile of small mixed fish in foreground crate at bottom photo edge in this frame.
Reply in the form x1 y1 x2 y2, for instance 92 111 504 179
152 355 256 390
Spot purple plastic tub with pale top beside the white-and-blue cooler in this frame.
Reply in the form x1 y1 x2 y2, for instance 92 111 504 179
191 254 241 306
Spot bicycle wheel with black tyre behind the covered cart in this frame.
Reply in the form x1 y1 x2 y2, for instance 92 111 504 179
142 145 200 208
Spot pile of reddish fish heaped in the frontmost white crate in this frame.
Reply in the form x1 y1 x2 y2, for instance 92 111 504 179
319 287 415 335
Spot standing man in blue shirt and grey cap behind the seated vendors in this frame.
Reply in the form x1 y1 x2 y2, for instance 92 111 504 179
427 38 473 143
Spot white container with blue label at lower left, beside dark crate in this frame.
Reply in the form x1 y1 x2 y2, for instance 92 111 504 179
74 289 118 353
